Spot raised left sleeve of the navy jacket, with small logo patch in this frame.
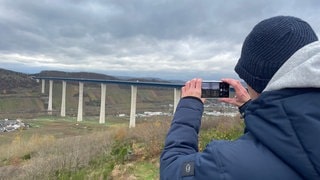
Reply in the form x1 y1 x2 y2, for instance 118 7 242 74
160 97 221 179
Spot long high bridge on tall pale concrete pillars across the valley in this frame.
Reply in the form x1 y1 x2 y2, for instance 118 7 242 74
33 76 184 128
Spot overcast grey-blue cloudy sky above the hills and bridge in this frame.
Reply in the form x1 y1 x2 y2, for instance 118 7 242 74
0 0 320 80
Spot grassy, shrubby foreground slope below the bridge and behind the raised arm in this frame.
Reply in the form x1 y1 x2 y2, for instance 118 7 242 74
0 114 243 180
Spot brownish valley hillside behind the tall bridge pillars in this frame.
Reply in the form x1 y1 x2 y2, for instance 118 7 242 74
0 69 173 118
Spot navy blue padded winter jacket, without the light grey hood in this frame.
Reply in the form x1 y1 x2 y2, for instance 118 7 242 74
160 88 320 180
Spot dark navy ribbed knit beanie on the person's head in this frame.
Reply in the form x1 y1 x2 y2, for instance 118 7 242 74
235 16 318 93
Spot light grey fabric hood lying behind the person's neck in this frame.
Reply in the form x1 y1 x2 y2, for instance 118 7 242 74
264 41 320 91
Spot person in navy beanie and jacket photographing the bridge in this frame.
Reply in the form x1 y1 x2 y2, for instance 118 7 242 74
160 16 320 180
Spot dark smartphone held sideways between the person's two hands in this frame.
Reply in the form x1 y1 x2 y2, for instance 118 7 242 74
201 81 230 98
